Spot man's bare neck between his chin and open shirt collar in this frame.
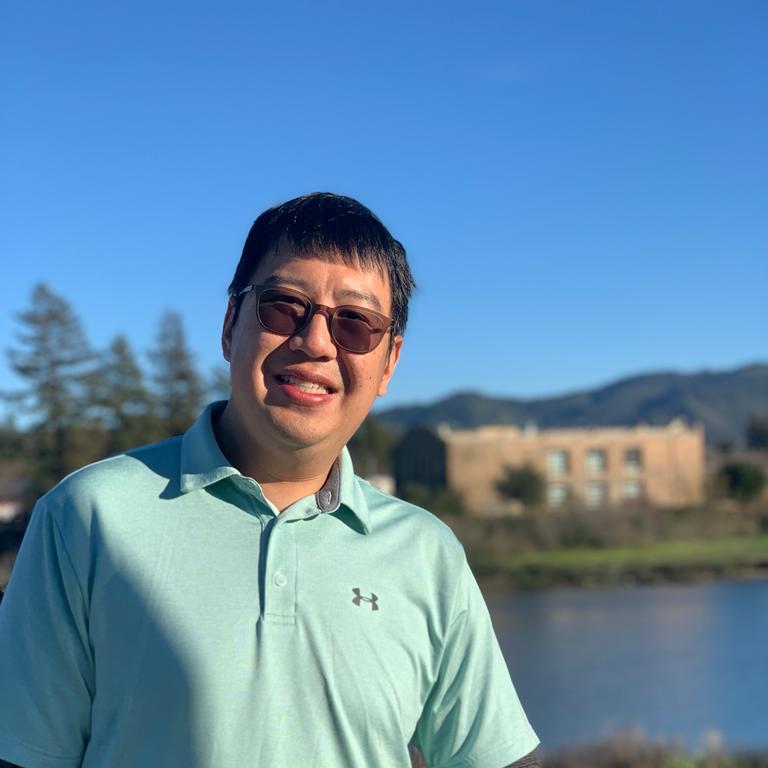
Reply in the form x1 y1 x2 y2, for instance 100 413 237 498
213 403 340 512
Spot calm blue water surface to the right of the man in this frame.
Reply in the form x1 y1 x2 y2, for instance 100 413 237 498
486 581 768 747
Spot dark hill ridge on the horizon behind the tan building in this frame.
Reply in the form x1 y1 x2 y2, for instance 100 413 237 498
376 363 768 445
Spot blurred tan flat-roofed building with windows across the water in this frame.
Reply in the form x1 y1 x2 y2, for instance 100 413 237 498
393 420 705 514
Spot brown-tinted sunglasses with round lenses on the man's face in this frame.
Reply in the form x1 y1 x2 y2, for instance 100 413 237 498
236 284 392 355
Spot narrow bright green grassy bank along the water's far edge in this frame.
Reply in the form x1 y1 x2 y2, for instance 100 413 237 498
468 534 768 589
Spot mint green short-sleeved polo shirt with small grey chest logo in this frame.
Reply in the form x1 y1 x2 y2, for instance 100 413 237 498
0 404 538 768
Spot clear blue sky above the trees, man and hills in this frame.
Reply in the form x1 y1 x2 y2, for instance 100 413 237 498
0 0 768 414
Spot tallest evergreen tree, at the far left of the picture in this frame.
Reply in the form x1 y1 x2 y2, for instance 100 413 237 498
8 283 99 496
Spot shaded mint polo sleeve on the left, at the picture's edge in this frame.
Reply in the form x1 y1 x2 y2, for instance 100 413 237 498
0 500 93 768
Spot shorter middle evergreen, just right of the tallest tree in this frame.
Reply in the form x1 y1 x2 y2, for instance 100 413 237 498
96 335 158 455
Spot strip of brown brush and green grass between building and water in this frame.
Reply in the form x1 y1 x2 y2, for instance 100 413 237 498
438 505 768 588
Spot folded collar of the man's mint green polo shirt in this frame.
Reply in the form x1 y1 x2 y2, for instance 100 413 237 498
179 400 370 533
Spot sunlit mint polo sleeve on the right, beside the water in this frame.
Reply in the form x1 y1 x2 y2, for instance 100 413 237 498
413 561 539 768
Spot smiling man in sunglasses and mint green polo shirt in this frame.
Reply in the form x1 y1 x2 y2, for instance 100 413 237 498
0 194 537 768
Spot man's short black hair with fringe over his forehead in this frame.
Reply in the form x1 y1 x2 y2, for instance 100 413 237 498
229 192 415 334
